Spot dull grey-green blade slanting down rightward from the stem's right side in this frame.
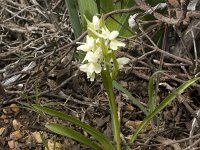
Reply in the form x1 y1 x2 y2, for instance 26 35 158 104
113 80 148 115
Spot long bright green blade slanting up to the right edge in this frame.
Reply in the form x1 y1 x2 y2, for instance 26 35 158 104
130 77 200 142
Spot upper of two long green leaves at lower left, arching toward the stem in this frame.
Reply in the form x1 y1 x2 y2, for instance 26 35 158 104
33 104 114 150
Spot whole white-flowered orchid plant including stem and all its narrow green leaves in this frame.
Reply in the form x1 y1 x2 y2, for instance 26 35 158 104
32 16 200 150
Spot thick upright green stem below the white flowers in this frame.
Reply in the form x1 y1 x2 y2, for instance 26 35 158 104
102 70 121 150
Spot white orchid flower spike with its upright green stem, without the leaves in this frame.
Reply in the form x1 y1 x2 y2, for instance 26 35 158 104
77 16 129 150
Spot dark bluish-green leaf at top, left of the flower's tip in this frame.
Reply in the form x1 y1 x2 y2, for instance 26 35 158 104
65 0 82 38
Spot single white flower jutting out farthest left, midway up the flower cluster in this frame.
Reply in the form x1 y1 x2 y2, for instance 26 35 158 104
77 35 95 52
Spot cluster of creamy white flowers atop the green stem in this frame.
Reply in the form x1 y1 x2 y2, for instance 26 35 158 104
77 16 129 81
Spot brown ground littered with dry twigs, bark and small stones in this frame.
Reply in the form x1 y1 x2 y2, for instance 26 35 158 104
0 0 200 150
